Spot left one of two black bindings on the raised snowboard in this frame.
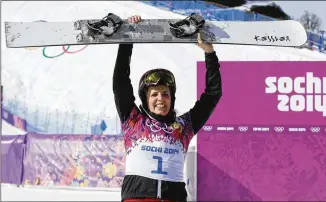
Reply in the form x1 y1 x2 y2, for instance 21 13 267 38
87 13 123 37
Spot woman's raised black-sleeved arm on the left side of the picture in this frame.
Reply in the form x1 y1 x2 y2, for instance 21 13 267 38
113 44 135 123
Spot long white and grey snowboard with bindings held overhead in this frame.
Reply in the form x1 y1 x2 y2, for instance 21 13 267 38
5 13 307 48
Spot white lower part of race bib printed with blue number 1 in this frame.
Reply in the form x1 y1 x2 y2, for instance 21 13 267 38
126 141 185 182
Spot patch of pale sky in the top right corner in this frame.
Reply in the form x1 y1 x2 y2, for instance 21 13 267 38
274 1 326 31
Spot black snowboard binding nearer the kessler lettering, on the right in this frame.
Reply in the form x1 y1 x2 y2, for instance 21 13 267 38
169 13 205 38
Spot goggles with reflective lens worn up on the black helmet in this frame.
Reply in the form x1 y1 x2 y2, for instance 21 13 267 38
144 70 176 88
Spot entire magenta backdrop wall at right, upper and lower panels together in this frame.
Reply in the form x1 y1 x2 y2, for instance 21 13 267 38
197 62 326 201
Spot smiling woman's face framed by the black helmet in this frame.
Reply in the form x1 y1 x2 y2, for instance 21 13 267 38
146 85 171 116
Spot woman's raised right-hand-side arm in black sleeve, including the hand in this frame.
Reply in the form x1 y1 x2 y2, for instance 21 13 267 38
190 36 222 134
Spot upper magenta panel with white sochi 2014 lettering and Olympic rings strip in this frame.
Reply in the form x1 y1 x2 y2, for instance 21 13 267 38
197 62 326 134
